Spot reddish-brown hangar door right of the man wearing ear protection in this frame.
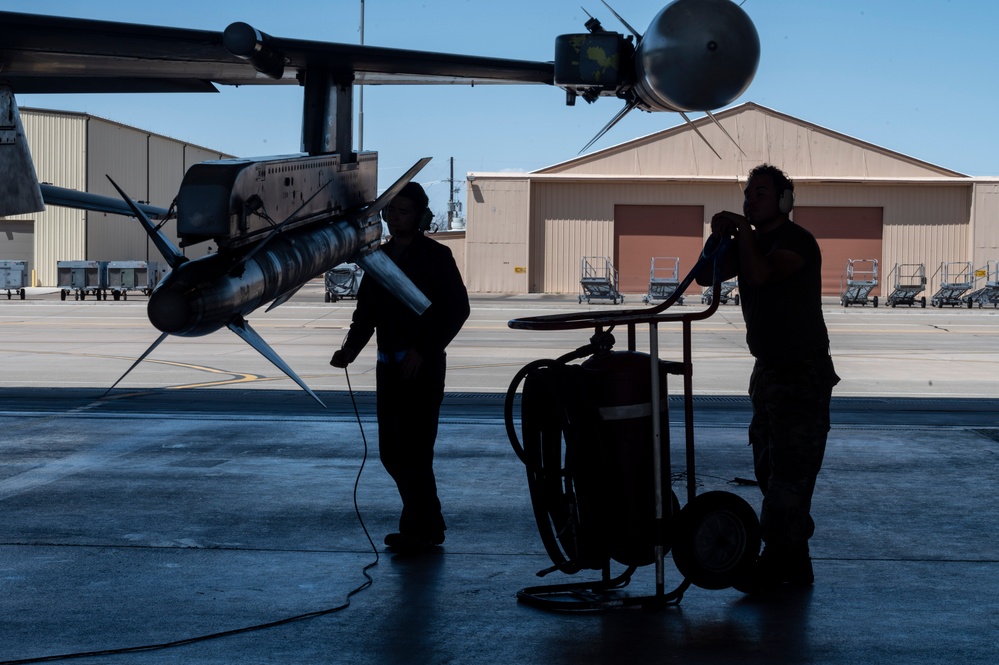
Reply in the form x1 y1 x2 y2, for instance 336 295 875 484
791 206 890 296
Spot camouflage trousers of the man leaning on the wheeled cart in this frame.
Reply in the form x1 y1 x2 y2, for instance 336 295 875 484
749 354 839 552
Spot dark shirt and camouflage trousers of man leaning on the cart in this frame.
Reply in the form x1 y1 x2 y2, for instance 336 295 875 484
739 221 839 553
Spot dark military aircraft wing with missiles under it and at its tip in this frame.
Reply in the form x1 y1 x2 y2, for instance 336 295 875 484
0 0 760 403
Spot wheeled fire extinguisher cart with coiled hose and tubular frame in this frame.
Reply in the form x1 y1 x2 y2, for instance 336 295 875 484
504 238 761 611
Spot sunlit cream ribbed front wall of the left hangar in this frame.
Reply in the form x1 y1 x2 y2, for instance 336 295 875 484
18 109 88 286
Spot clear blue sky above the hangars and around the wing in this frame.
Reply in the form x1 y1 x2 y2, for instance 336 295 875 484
7 0 999 220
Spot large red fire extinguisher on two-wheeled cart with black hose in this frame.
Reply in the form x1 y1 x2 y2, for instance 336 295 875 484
504 240 761 611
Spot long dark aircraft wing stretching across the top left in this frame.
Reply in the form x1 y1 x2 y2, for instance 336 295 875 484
0 12 555 94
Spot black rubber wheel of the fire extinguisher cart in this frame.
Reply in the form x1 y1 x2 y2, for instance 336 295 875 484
673 491 760 589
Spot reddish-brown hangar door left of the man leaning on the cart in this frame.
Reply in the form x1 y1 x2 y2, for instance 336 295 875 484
612 205 704 293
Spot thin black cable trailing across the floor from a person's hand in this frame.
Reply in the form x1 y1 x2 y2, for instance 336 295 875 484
0 368 380 665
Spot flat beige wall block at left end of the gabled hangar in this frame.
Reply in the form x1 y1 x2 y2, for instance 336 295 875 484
463 177 534 293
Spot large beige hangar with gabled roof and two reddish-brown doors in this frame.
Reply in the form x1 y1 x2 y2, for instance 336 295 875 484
465 103 999 300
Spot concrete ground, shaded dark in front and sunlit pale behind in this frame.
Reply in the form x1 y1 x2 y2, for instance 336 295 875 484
0 285 999 664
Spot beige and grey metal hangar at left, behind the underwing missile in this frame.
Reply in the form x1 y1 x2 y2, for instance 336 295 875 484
0 108 228 286
